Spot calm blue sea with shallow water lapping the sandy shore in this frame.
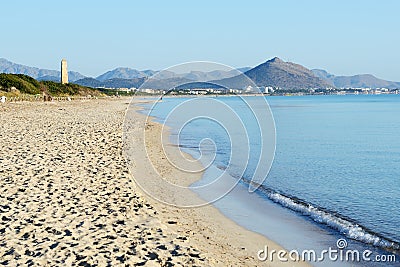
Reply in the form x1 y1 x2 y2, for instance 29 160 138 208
138 95 400 266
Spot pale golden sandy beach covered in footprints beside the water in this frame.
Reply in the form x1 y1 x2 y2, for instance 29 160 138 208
0 98 304 266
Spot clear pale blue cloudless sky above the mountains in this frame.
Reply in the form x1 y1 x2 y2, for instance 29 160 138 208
0 0 400 81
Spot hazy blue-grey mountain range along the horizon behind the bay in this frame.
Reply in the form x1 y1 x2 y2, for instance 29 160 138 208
0 57 400 90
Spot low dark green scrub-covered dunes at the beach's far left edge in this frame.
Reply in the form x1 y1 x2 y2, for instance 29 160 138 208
0 73 103 96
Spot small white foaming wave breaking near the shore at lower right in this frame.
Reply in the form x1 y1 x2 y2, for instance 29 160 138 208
244 180 400 253
